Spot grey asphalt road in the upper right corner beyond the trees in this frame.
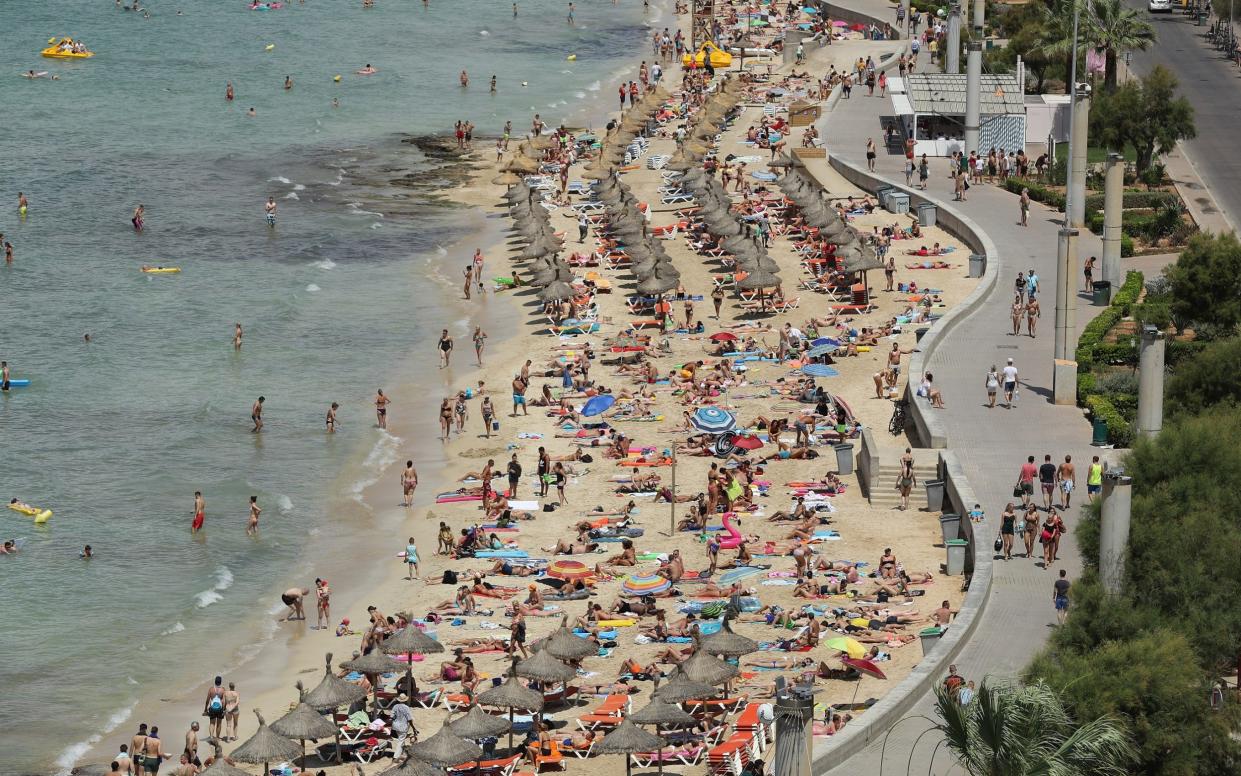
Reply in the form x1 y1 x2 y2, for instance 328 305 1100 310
1128 0 1241 229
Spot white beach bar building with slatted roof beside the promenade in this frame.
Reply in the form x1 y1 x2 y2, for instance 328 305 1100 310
887 73 1026 156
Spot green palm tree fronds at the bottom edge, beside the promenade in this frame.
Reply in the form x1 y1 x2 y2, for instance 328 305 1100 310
936 680 1137 776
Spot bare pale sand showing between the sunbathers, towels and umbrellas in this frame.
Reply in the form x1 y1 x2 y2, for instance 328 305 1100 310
82 6 974 774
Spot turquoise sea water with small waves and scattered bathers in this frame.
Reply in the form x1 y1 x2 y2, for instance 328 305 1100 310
0 0 671 774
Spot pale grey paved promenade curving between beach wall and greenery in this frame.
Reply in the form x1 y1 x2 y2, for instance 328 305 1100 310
820 0 1131 776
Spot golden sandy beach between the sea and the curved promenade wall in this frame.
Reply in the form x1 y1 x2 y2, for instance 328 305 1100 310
75 3 974 774
